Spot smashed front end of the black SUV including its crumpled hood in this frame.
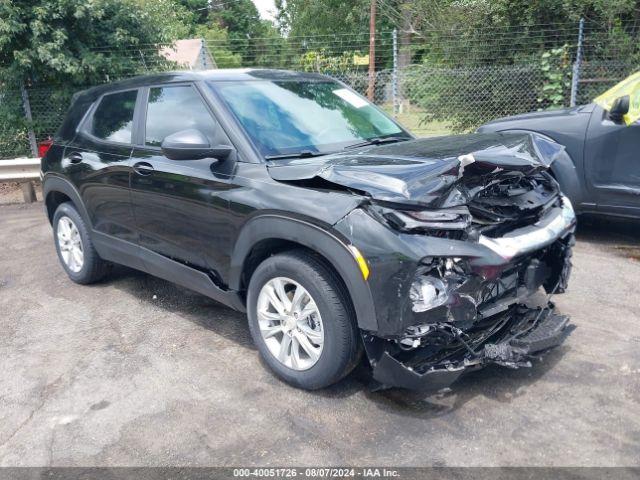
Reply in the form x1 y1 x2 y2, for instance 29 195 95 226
269 130 575 391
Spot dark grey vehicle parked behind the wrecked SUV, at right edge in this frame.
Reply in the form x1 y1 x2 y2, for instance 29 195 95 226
478 92 640 218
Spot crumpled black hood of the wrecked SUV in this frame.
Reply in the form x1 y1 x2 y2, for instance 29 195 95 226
268 133 564 207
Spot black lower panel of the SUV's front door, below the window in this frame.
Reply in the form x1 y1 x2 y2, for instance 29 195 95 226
131 153 232 271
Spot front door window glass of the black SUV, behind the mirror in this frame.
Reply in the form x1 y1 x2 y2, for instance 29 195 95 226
145 85 215 146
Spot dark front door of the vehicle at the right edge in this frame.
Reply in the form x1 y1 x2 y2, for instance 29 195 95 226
584 106 640 216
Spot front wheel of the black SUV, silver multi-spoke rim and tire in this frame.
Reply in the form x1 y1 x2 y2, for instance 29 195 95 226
247 250 361 390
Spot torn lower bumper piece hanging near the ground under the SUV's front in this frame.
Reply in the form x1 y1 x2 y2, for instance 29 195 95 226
363 304 571 392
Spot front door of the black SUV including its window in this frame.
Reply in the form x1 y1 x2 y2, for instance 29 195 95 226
131 84 233 274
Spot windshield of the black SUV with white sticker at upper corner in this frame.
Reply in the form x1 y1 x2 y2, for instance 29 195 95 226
210 80 409 157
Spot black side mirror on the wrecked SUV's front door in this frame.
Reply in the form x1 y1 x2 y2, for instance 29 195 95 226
160 128 233 161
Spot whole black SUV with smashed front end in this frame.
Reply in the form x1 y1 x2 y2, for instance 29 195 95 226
42 70 575 390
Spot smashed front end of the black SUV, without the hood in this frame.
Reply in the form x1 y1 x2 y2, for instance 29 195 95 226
324 131 575 392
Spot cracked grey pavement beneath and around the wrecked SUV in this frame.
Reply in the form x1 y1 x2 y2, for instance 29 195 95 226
0 204 640 466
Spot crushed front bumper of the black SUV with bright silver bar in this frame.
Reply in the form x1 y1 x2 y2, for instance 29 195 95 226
336 194 576 391
